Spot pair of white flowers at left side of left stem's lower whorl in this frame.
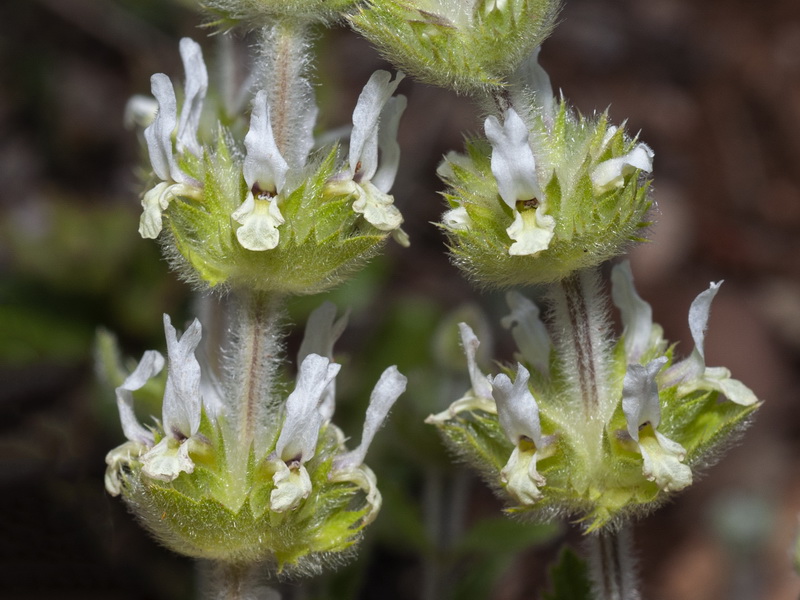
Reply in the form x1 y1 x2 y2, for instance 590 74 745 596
106 315 211 494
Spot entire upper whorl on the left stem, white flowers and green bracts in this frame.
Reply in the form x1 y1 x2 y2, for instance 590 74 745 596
139 37 408 295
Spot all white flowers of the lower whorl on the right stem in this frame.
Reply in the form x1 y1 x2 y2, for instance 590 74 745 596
427 262 758 505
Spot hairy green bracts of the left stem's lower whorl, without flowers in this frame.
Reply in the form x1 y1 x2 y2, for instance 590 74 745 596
112 415 371 572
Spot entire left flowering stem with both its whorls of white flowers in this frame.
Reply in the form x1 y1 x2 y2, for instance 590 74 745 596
105 0 416 600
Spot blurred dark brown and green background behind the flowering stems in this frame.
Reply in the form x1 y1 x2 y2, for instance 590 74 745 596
0 0 800 600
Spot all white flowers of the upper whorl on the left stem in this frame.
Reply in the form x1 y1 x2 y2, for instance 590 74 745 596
136 38 406 251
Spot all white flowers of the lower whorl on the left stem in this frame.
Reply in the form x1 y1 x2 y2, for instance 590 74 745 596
106 303 406 514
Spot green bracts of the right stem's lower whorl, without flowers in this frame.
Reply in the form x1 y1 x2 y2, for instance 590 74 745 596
437 371 756 530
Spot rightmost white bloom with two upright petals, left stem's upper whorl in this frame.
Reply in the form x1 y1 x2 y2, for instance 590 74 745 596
332 71 406 231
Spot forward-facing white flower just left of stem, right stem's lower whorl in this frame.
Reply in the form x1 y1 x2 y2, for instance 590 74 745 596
491 363 547 504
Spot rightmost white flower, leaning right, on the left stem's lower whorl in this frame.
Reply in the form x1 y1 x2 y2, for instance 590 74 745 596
329 367 408 524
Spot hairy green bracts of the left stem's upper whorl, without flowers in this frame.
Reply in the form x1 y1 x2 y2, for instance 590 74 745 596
164 142 388 294
